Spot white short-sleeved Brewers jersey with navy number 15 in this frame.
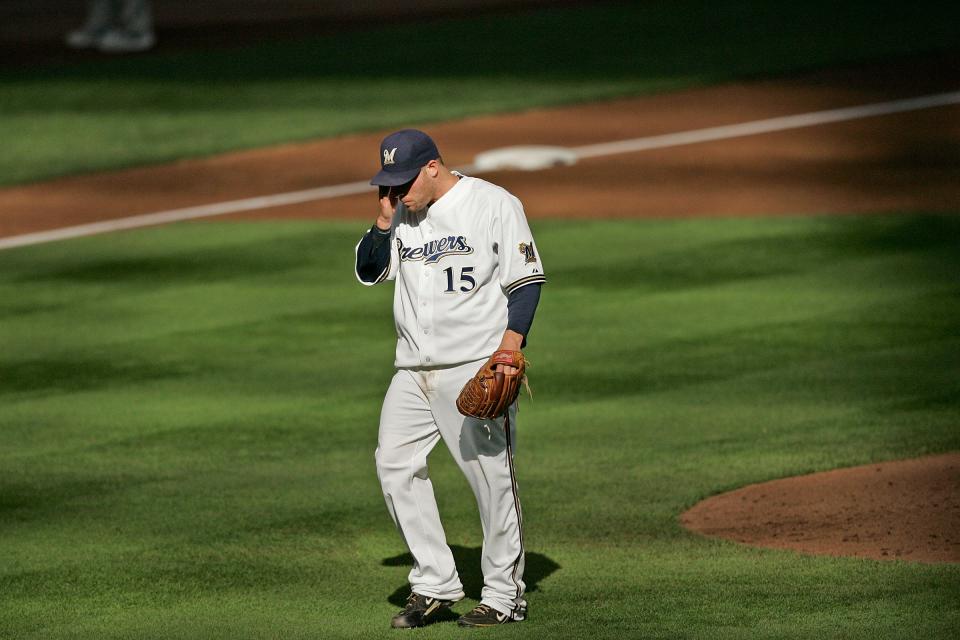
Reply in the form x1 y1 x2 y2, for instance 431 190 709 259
357 174 546 368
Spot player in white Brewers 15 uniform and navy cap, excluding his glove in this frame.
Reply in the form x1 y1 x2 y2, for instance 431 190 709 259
356 129 546 628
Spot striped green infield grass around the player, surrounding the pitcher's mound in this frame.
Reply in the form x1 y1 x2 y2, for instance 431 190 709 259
0 215 960 638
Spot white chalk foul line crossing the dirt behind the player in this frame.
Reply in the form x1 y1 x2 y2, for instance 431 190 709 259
0 91 960 250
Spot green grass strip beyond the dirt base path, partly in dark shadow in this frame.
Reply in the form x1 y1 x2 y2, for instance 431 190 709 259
0 0 960 184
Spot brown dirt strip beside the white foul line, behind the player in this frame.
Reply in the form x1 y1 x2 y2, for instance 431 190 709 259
0 52 960 237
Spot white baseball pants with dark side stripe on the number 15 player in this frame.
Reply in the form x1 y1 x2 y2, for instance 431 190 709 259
377 360 526 620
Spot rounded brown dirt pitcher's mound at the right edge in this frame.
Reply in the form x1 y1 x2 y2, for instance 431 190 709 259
680 452 960 562
